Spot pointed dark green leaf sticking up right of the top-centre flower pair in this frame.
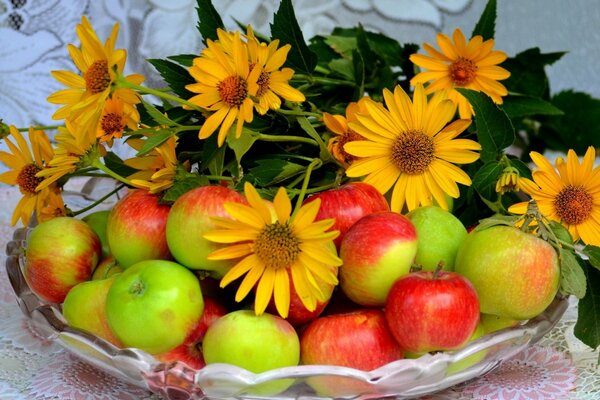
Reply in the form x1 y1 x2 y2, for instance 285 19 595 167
271 0 317 75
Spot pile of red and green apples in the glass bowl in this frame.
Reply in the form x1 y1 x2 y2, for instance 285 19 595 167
19 182 560 394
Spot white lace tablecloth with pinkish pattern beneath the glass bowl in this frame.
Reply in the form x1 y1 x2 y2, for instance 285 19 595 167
0 185 600 400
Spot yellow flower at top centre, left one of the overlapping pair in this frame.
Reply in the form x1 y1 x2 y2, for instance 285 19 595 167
186 32 261 146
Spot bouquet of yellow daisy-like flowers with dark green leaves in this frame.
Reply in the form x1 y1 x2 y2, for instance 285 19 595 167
0 0 600 394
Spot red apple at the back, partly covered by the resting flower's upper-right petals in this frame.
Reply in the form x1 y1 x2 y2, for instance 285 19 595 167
304 182 390 250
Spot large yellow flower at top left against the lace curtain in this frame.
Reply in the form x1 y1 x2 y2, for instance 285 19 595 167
48 17 144 130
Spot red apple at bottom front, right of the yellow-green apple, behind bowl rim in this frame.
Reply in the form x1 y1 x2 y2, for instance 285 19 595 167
300 309 403 397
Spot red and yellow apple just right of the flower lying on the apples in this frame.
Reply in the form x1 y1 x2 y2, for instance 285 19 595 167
339 211 417 307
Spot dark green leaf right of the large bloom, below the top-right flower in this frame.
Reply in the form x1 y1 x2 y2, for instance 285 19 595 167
457 88 515 162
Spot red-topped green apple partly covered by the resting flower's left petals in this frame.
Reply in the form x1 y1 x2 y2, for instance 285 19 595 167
166 185 246 278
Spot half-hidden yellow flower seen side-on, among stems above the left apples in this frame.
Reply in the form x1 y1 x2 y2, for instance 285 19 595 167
125 136 177 193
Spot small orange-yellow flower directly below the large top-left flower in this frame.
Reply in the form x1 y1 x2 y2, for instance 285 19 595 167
96 96 140 146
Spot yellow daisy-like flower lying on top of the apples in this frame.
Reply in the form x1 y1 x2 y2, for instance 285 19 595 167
204 182 342 318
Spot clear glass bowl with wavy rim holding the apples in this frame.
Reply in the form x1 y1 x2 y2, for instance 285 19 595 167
6 182 568 400
